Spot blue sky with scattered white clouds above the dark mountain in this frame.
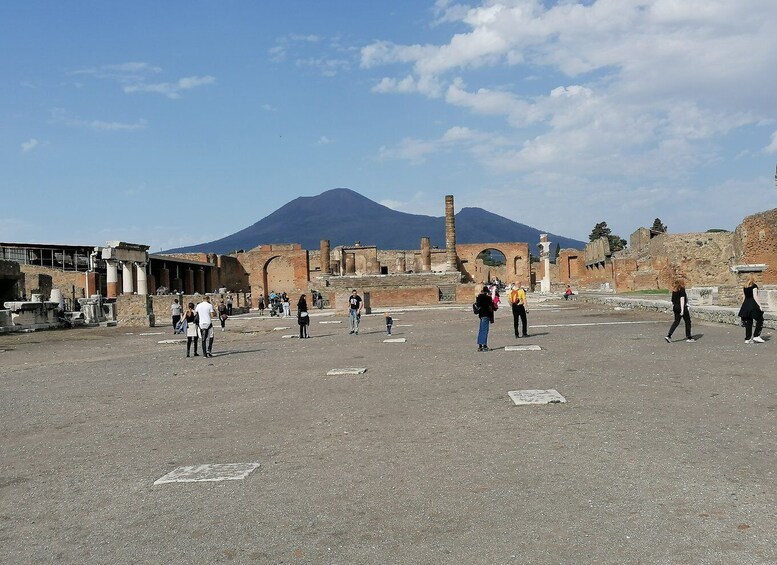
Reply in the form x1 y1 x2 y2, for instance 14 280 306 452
0 0 777 250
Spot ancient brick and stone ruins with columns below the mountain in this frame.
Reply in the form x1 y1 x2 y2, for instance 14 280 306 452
0 200 777 329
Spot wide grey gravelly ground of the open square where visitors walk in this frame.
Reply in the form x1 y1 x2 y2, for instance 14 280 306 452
0 301 777 564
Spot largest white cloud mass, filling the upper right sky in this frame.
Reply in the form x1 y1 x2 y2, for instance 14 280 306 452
360 0 777 183
